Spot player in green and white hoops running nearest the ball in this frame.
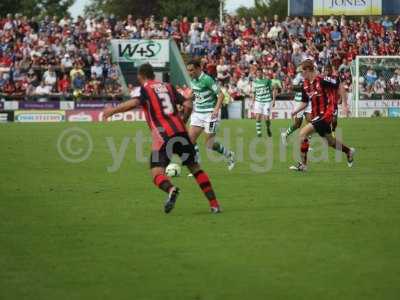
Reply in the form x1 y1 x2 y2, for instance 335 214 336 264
187 60 235 171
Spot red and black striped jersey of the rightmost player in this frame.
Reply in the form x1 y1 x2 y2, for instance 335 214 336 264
302 76 339 120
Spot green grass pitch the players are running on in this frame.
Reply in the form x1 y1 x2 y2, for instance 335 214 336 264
0 119 400 300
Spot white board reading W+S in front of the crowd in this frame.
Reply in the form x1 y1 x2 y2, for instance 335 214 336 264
111 40 169 66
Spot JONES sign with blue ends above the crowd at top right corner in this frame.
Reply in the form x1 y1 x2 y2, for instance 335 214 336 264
288 0 400 16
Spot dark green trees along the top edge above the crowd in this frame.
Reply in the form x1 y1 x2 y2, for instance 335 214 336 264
0 0 287 19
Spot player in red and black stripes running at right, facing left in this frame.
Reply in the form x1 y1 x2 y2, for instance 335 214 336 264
290 60 355 171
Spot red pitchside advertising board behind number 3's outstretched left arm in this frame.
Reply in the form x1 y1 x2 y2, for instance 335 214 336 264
66 109 145 122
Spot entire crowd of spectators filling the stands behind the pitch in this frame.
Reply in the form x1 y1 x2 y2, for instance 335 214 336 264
0 14 400 100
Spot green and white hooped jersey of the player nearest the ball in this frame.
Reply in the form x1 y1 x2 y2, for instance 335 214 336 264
190 73 220 114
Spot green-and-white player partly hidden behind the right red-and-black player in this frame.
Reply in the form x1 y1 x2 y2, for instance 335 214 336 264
281 73 311 145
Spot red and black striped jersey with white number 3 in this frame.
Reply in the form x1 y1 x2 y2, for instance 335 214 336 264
139 80 186 142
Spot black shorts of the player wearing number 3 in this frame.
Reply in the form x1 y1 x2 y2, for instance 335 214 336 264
150 133 197 169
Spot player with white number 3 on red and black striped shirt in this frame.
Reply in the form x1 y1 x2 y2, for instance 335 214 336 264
104 64 221 213
